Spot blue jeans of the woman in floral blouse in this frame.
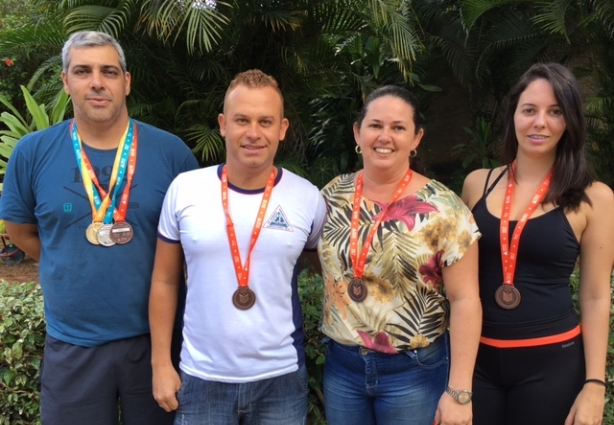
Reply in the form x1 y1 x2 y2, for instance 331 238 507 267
324 334 450 425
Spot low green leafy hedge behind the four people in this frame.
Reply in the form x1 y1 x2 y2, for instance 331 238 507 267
0 271 614 425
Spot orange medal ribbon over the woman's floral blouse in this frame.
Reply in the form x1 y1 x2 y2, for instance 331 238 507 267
350 170 413 279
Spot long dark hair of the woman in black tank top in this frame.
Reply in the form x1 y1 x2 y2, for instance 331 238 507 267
502 63 594 210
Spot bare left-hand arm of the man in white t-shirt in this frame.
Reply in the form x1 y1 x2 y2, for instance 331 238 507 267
149 239 183 412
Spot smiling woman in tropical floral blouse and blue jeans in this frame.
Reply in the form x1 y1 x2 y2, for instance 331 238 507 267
318 86 482 425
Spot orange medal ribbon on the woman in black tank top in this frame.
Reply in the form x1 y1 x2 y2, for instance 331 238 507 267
499 161 553 286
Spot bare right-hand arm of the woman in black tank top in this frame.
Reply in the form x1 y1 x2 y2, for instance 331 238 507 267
565 183 614 425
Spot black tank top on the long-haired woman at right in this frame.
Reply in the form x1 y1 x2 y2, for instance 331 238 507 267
472 172 580 339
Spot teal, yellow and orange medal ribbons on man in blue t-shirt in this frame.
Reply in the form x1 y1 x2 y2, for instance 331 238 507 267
70 120 137 224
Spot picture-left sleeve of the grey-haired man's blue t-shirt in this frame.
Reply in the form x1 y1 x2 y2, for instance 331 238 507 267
0 139 37 224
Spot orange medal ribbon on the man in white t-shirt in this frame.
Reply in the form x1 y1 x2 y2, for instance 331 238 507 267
222 166 277 287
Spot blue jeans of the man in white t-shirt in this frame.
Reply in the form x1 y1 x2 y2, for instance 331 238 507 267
175 365 309 425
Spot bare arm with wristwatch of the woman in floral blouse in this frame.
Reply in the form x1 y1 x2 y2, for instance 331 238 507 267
436 242 482 425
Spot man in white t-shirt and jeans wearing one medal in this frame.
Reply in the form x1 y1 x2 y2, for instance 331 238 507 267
149 70 326 425
